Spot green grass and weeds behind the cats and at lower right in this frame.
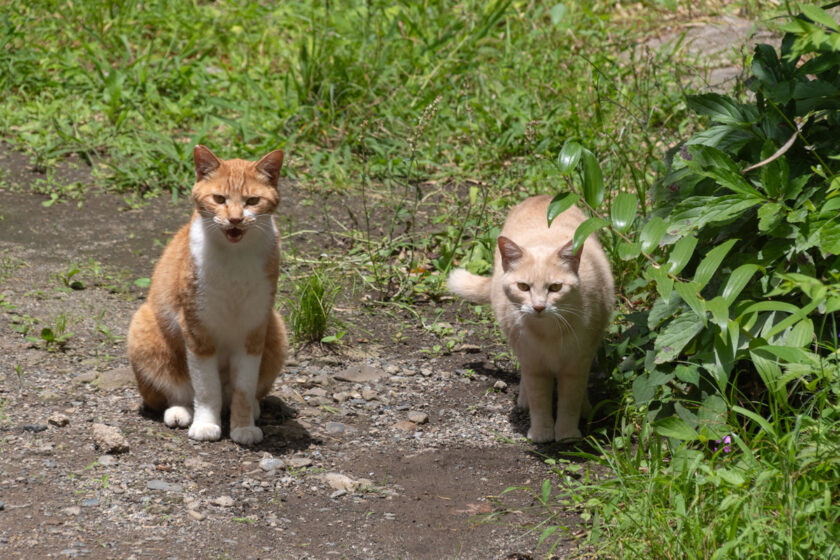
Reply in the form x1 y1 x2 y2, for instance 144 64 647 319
0 0 840 559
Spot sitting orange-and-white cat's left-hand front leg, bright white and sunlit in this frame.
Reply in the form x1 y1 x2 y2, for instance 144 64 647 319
187 350 222 441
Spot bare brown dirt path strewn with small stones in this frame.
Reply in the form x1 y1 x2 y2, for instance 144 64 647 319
0 150 576 559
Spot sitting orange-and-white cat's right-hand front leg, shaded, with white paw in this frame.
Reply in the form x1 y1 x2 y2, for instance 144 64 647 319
230 353 263 445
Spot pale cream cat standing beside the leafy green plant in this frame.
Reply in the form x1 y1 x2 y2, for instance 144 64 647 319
448 196 615 442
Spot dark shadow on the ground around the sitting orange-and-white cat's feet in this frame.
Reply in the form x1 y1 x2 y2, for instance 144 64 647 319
140 395 321 455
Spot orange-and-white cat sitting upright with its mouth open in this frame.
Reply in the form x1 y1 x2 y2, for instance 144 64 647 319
128 146 288 445
